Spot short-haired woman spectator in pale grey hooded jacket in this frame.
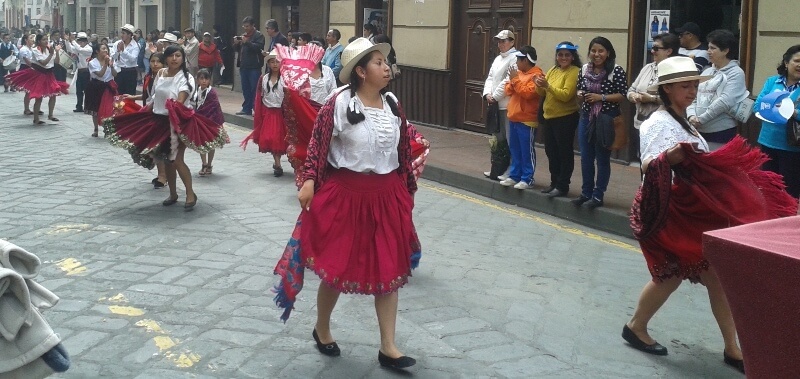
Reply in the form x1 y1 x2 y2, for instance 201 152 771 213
686 29 749 145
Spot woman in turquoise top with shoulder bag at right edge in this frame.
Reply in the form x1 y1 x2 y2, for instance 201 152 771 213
753 45 800 197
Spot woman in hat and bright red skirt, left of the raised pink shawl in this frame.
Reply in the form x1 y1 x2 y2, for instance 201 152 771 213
240 50 287 177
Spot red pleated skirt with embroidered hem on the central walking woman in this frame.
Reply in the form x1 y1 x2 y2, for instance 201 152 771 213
300 168 419 295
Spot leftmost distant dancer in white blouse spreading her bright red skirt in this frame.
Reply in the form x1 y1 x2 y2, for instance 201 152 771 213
6 34 69 125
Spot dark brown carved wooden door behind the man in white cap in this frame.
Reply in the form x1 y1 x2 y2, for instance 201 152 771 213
453 0 531 133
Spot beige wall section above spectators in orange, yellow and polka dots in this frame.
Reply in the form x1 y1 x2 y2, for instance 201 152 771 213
532 0 630 72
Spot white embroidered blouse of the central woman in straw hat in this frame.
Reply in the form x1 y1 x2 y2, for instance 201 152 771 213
328 90 401 174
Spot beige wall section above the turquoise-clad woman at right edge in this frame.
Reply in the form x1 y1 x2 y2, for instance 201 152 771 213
752 1 800 95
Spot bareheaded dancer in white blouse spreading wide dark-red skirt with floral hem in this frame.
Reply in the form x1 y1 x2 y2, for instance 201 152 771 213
103 45 228 211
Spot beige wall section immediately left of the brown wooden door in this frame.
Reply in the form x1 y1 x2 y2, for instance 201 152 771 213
392 0 450 70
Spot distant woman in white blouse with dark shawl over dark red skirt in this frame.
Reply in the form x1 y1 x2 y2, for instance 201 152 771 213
84 45 117 137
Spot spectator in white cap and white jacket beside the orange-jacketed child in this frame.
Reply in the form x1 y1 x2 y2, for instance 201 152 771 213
483 30 517 180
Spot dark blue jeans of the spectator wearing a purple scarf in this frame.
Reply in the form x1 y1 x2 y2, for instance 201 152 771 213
578 112 616 201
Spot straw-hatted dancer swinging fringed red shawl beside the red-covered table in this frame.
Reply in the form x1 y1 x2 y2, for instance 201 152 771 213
622 57 797 372
